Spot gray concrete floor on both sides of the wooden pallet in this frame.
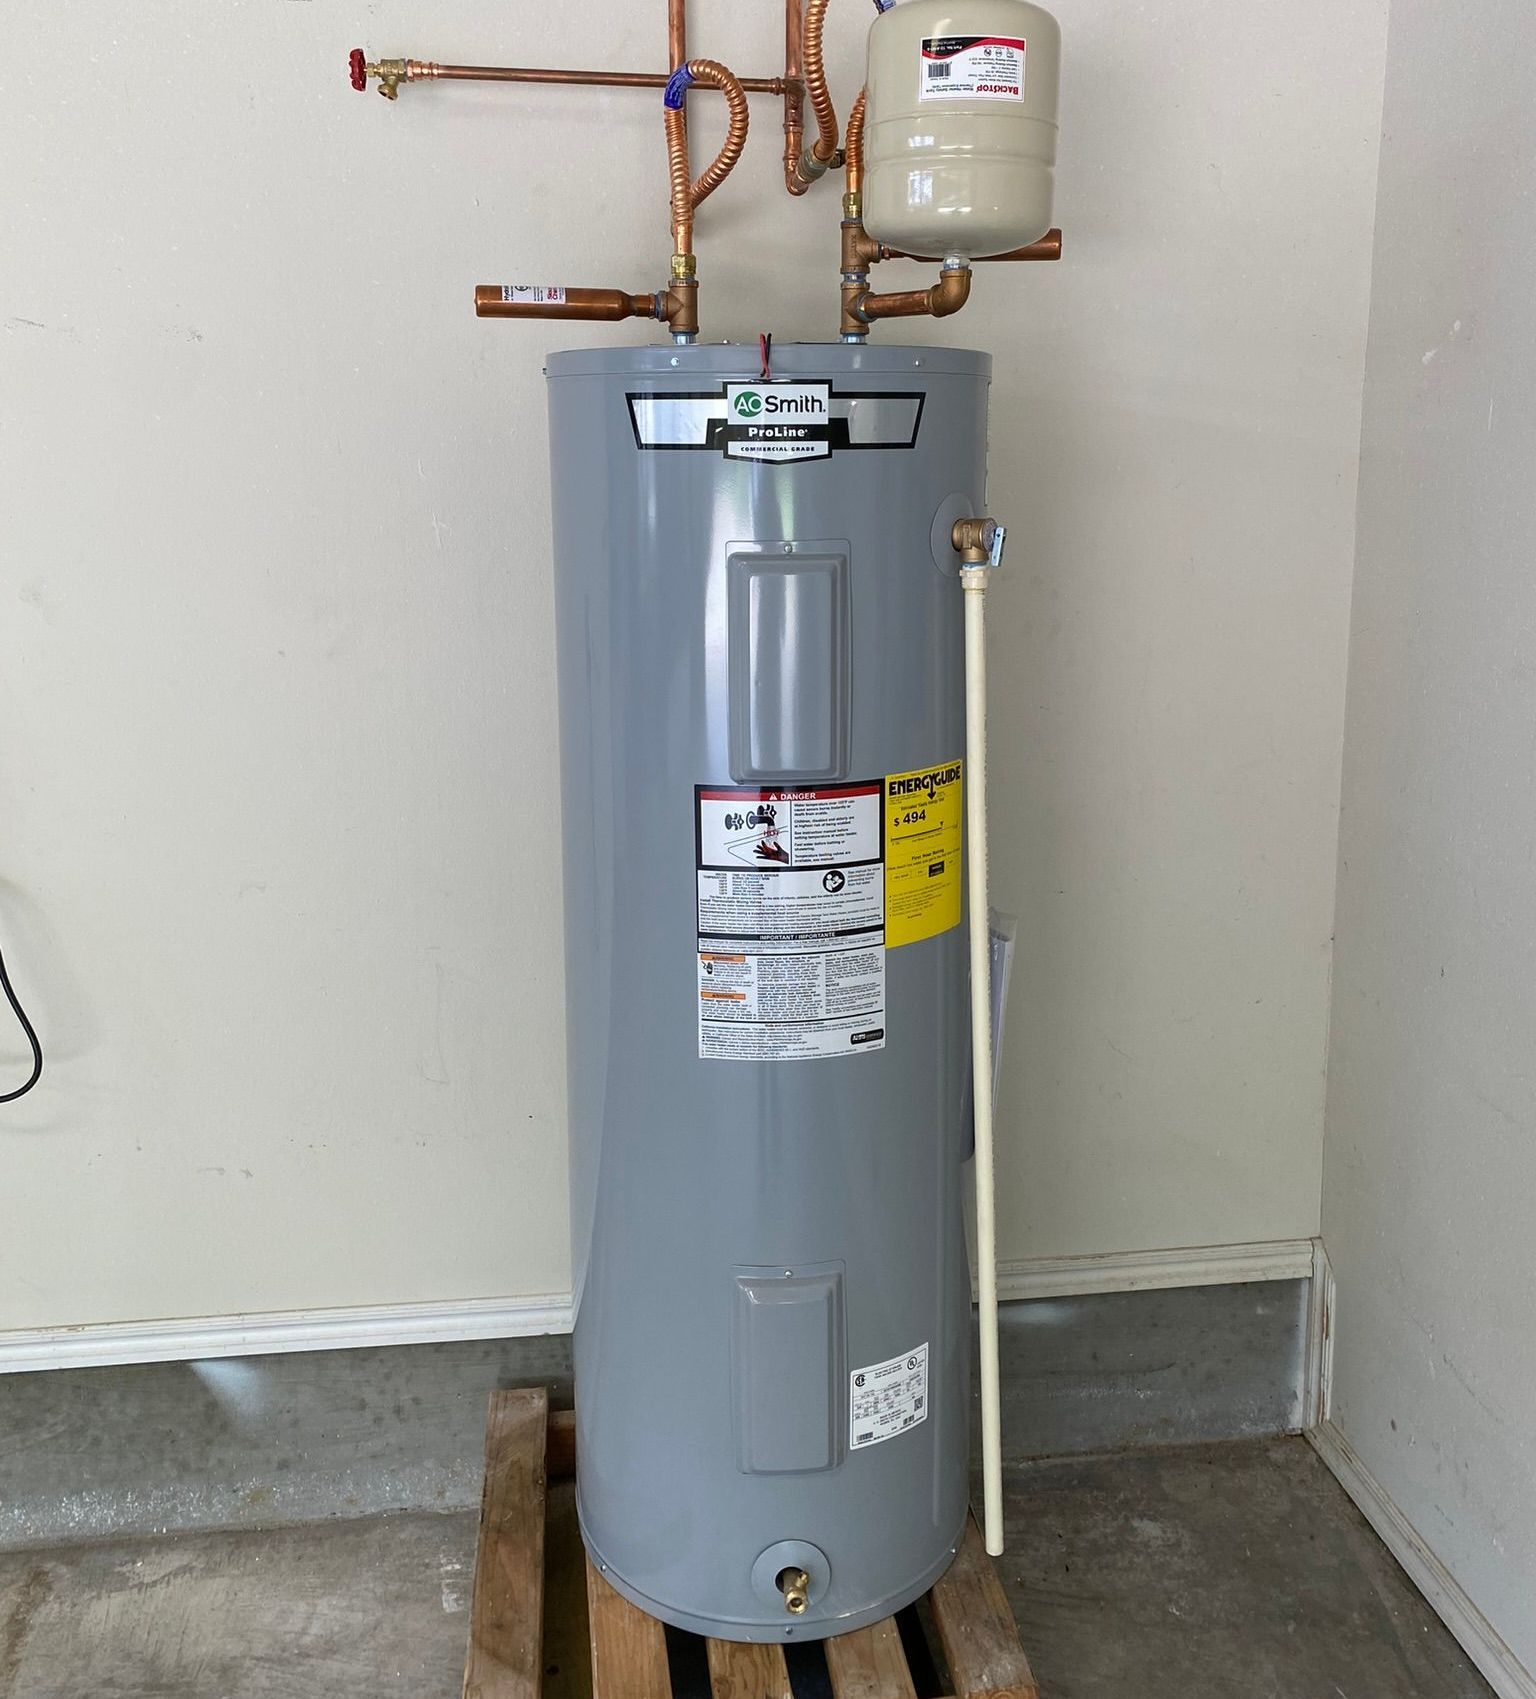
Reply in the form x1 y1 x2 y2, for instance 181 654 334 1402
0 1439 1490 1699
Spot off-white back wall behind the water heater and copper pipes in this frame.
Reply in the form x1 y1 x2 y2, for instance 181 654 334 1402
0 0 1383 1330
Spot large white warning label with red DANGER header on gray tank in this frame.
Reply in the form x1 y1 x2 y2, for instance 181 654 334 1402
693 780 885 1062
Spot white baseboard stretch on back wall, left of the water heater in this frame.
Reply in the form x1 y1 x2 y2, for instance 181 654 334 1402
0 1293 571 1374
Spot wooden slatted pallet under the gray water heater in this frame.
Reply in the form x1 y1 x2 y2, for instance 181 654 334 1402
464 1388 1038 1699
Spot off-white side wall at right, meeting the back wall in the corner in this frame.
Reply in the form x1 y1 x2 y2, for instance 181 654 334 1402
1324 0 1536 1670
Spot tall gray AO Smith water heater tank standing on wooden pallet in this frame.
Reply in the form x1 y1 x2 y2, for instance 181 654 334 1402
547 345 991 1641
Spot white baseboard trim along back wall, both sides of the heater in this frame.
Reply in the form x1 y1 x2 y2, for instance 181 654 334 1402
0 1239 1313 1374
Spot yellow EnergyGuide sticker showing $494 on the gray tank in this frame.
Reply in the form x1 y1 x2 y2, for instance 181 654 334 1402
885 761 965 950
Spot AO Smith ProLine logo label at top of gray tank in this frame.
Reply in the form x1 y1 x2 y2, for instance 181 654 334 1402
627 382 923 466
